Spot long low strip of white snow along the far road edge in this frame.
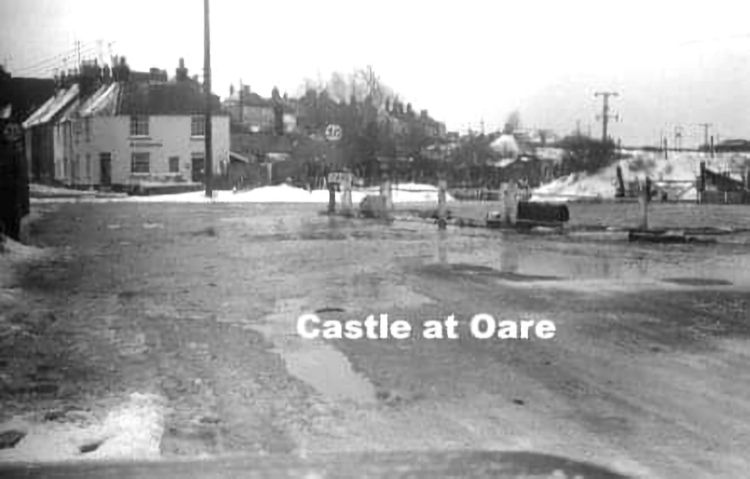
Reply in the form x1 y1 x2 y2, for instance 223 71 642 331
34 183 453 205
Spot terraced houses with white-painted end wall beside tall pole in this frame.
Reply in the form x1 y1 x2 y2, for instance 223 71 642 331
24 61 229 189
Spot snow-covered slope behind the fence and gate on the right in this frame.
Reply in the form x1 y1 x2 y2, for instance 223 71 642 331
532 152 750 201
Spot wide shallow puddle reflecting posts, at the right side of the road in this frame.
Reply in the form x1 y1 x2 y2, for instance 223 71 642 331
432 237 750 288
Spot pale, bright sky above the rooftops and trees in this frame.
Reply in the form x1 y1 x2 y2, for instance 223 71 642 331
0 0 750 146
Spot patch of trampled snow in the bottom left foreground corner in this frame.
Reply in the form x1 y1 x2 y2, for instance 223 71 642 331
0 393 164 462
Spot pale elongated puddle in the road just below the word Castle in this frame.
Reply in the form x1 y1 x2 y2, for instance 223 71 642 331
247 300 377 404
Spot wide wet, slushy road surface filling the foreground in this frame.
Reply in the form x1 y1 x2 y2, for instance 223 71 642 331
0 203 750 478
